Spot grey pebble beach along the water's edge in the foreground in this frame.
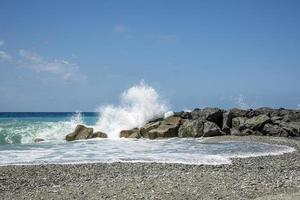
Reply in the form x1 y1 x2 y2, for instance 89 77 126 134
0 136 300 199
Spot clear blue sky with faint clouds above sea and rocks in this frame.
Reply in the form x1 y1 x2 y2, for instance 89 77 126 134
0 0 300 112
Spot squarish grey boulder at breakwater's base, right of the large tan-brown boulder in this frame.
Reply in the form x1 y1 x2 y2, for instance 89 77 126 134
178 119 204 137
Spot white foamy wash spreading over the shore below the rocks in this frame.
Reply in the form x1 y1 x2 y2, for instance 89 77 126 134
0 138 295 165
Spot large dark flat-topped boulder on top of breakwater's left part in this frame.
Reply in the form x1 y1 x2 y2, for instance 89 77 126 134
191 108 223 127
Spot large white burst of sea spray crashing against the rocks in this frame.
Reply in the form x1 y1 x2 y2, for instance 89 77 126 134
94 82 168 138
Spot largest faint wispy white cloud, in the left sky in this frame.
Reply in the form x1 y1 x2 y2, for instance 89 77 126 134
19 49 85 80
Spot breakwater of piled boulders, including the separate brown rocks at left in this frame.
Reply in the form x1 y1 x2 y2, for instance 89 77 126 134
66 108 300 141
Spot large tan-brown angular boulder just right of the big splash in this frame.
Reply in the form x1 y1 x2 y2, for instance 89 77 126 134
143 116 182 139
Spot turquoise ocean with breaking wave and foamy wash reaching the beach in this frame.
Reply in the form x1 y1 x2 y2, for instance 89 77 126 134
0 112 294 165
